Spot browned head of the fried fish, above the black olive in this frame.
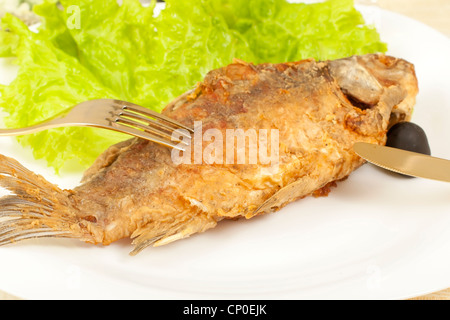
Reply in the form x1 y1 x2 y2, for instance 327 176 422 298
329 54 419 127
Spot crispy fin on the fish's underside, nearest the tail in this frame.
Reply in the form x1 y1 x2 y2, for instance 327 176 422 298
130 213 217 256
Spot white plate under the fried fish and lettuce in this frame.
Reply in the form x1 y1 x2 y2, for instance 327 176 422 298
0 7 450 299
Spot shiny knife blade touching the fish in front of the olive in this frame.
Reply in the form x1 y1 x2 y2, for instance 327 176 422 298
353 142 450 182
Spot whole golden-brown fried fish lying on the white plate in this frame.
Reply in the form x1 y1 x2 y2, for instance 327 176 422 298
0 54 418 254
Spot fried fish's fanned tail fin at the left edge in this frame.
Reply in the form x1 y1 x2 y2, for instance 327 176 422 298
0 155 93 245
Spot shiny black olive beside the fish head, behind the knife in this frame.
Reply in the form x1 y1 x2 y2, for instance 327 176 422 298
386 122 431 155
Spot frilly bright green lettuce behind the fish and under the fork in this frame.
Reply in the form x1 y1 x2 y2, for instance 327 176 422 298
0 0 387 172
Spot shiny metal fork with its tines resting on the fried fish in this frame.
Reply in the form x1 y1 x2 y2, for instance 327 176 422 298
0 99 194 151
